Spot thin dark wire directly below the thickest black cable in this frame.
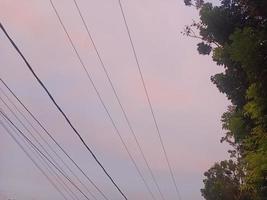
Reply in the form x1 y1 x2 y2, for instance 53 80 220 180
0 78 109 200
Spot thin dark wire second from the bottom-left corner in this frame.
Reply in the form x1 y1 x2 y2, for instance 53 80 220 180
0 110 90 200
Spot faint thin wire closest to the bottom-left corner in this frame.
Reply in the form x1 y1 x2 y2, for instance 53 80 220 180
0 117 68 200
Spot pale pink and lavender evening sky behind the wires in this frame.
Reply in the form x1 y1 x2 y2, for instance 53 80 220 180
0 0 230 200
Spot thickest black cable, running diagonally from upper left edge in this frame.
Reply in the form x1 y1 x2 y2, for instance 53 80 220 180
0 20 127 200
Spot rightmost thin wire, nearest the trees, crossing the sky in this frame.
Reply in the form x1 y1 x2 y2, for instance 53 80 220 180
118 0 181 199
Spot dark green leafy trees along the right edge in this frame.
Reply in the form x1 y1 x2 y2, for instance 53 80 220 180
183 0 267 200
